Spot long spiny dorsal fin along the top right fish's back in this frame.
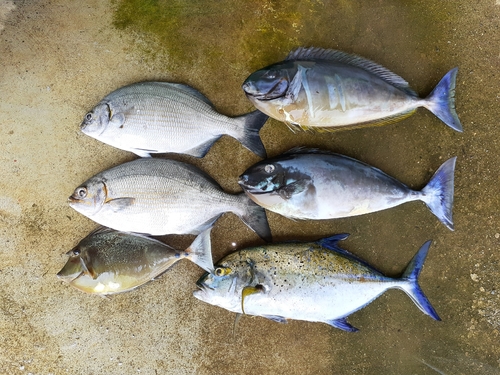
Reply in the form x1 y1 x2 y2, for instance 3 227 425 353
285 47 418 97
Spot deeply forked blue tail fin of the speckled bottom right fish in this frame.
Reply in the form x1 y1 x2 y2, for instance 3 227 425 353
400 241 441 320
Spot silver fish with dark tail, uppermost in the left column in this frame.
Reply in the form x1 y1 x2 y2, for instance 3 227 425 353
80 82 268 158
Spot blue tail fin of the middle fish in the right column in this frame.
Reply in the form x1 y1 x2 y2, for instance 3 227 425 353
421 157 457 230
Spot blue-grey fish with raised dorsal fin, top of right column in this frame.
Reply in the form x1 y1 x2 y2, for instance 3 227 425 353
242 47 463 132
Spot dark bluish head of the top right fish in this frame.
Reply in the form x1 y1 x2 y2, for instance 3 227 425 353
242 63 296 100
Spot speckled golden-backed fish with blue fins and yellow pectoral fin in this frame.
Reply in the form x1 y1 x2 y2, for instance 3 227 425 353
193 234 441 332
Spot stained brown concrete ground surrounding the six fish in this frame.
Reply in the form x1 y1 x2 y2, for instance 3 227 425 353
0 0 500 374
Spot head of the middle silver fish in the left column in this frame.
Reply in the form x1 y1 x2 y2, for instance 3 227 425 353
68 178 108 216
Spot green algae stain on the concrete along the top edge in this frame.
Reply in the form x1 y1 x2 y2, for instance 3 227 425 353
113 0 319 76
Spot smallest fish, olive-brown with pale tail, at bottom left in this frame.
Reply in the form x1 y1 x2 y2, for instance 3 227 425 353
57 227 213 295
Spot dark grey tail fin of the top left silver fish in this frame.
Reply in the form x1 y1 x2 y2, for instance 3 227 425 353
234 111 269 159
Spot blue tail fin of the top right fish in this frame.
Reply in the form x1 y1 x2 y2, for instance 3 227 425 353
424 68 463 132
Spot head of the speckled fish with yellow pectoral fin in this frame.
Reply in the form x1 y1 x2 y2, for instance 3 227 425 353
193 262 252 312
